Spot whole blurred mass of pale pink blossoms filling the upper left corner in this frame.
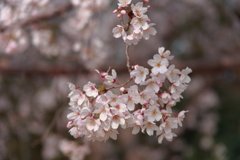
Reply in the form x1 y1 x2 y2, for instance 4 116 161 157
0 0 109 57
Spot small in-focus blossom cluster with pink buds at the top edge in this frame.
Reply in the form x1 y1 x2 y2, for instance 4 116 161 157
112 0 157 45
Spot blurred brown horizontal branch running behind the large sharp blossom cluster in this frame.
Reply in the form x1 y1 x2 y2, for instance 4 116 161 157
0 56 240 76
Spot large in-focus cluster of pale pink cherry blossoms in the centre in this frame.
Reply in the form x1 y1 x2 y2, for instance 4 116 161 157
67 47 191 143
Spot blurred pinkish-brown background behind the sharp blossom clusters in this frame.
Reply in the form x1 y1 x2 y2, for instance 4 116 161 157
0 0 240 160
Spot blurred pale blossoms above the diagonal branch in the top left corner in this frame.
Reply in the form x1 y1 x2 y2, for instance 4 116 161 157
0 0 64 27
